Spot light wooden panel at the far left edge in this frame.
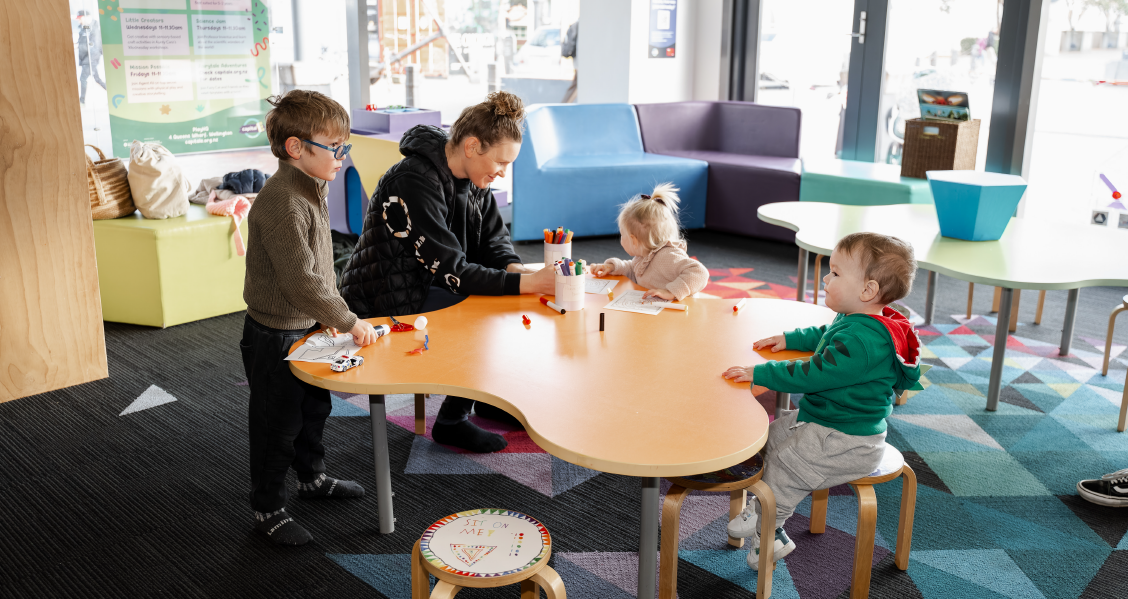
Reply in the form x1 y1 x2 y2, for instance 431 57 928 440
0 0 108 402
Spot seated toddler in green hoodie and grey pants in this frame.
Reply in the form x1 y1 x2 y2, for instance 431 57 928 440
724 232 920 570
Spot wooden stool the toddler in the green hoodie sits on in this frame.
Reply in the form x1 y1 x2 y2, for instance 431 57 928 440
811 443 916 599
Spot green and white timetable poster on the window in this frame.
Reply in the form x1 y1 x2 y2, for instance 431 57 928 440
98 0 271 158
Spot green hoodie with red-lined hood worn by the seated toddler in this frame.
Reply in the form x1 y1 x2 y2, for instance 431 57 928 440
752 306 920 435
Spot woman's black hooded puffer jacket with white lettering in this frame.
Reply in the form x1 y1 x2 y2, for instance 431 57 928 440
341 125 521 318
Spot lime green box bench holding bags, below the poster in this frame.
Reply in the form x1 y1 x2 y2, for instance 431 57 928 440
94 204 247 327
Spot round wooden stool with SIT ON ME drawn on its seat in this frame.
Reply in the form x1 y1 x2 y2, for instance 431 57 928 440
412 509 567 599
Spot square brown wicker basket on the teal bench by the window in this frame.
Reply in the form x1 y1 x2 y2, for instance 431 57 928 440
901 118 979 179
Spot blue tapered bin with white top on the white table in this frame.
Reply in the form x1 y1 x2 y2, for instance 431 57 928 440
925 170 1026 241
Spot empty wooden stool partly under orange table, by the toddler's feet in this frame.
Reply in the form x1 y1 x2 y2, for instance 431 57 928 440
658 455 775 599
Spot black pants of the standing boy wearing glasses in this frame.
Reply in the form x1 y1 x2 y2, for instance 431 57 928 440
239 315 333 512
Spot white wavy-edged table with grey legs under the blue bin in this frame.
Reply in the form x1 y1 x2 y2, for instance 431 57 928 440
758 202 1128 411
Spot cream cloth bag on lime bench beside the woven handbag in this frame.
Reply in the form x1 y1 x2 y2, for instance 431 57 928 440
130 141 192 219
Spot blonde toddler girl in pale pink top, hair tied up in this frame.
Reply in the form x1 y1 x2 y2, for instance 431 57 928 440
591 183 708 300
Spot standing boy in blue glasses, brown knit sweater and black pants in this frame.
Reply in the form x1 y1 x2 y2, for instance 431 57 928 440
239 89 376 545
